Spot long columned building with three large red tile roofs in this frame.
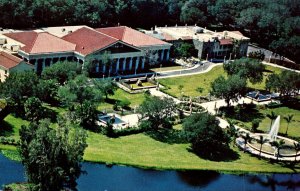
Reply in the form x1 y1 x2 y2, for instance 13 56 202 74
0 26 171 75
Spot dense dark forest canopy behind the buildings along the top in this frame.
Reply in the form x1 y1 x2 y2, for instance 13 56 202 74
0 0 300 62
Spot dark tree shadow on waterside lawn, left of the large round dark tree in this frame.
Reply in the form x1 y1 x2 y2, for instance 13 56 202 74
145 128 188 144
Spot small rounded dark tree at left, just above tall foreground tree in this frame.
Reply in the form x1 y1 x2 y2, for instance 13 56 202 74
24 97 44 122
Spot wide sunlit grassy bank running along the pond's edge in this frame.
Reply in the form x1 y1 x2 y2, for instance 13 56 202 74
0 116 300 172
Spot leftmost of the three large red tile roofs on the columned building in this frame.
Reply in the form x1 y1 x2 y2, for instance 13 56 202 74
4 31 75 54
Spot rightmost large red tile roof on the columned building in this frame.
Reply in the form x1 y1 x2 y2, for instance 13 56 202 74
96 26 168 47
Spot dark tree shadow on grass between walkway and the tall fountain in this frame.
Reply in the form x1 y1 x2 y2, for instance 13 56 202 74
219 104 265 122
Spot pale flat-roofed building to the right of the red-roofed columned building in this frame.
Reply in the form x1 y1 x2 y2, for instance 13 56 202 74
144 26 250 59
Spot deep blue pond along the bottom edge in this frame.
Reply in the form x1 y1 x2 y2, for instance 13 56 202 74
0 154 300 191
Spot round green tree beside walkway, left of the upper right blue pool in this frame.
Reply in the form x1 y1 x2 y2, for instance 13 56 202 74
210 75 246 107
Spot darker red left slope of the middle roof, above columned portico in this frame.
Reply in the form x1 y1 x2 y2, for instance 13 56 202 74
62 27 119 55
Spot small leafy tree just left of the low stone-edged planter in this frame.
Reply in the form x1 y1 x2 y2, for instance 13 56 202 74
94 78 117 100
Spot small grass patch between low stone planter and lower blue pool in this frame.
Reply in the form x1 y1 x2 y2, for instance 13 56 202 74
98 88 145 111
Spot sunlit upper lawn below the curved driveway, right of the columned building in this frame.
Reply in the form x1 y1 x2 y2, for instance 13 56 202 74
159 66 282 97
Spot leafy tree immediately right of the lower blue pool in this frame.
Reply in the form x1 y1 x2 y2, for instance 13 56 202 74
138 96 176 130
